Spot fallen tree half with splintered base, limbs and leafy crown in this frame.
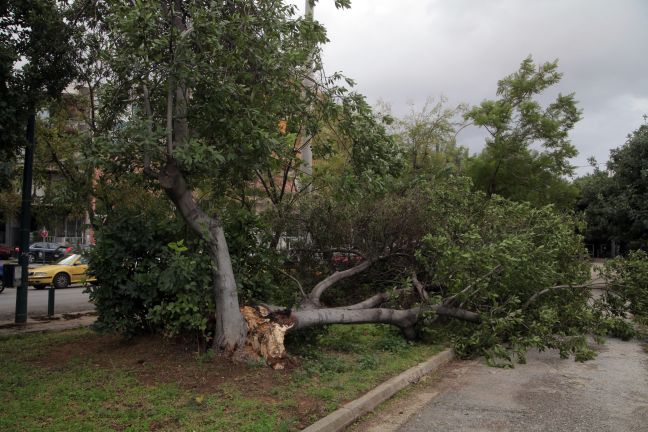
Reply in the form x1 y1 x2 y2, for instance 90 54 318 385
227 178 625 367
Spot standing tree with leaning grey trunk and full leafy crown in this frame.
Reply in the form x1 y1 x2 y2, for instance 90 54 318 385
87 0 370 353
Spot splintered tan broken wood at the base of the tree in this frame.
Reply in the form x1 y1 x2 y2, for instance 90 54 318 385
241 306 294 369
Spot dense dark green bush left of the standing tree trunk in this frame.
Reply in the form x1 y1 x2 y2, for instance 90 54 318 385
88 193 190 336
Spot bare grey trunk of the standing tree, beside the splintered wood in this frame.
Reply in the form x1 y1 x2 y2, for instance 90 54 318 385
159 159 247 354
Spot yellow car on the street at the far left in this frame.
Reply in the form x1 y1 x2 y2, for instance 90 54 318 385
27 254 96 289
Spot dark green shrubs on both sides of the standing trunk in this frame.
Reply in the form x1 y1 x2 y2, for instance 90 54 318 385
88 189 296 339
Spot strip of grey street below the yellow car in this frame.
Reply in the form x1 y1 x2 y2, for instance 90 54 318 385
0 286 94 321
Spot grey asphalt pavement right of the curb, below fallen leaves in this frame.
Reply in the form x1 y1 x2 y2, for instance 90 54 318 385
394 339 648 432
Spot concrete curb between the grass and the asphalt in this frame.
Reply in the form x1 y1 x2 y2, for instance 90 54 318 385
303 349 454 432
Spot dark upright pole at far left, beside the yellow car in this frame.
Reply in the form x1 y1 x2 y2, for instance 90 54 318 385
15 110 36 324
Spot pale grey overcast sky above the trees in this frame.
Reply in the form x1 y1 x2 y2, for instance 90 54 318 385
292 0 648 174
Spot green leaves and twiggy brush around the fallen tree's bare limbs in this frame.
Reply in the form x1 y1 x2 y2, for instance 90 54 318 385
297 171 612 366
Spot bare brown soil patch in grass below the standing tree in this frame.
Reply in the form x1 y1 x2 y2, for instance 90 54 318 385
33 335 325 427
